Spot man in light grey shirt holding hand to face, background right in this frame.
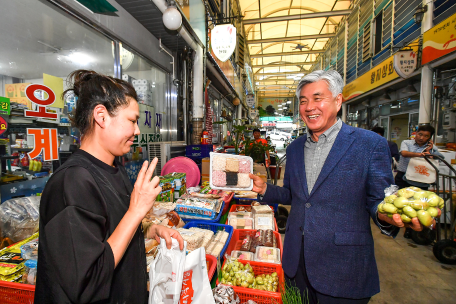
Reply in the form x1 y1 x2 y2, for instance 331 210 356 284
394 125 443 239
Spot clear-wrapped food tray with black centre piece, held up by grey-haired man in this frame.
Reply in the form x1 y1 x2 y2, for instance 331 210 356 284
209 152 253 190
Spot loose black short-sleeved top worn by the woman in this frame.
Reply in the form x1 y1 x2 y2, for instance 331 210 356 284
35 150 147 304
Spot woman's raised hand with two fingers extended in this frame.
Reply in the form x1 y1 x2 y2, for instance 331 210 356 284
128 158 161 220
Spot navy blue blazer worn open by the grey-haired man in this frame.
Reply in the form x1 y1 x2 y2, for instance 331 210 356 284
262 124 399 299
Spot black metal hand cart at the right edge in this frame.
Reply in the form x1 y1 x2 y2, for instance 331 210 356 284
424 155 456 264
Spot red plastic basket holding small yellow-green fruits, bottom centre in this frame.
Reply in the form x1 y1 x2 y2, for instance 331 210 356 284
216 260 284 304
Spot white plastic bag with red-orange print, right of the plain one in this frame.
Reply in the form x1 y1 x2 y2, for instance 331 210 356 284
179 248 215 304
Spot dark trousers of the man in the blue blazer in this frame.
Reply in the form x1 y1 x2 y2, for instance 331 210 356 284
285 241 370 304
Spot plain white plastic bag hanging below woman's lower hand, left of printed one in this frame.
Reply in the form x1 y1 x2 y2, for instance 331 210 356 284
149 238 186 304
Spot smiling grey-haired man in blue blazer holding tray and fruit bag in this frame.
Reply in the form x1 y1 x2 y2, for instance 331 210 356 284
250 70 420 304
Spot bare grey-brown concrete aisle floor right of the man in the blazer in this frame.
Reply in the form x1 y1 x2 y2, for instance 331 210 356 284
277 151 456 304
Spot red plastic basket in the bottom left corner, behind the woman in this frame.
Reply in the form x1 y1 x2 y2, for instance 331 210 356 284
0 281 35 304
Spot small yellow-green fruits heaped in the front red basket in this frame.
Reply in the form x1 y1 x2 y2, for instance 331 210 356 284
220 256 279 292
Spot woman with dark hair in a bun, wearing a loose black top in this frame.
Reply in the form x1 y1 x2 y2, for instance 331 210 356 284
35 70 183 304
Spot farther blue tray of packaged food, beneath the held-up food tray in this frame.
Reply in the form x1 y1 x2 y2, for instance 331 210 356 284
175 194 223 220
